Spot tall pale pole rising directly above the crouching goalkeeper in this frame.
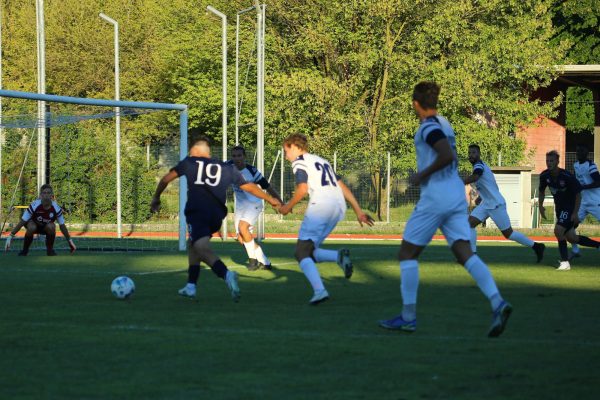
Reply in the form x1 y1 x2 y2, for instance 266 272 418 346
35 0 48 192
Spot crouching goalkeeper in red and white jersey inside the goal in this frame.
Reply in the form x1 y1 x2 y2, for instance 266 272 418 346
5 184 77 256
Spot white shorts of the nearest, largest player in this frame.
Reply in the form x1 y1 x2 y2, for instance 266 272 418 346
402 202 471 247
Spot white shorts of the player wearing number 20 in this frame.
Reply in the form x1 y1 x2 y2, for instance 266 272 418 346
298 206 346 247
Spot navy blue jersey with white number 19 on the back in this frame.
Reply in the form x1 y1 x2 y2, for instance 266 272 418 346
172 156 247 218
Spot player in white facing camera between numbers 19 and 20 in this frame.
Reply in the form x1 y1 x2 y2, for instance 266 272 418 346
231 146 283 271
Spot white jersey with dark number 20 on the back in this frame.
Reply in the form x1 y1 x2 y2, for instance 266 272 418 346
292 153 346 210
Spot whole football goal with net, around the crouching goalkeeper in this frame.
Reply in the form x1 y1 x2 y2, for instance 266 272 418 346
0 90 187 251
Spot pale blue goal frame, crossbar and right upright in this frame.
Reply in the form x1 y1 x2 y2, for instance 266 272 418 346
0 90 188 251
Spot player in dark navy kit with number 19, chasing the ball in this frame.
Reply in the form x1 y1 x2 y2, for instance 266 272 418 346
150 136 281 302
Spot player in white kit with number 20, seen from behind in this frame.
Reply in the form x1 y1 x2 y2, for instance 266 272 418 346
279 134 373 305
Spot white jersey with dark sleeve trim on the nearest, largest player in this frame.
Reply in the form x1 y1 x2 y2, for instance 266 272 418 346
415 115 466 209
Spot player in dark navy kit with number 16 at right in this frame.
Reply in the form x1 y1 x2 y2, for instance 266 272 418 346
539 150 600 271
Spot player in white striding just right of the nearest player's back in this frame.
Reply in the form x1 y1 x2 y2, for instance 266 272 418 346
464 144 546 263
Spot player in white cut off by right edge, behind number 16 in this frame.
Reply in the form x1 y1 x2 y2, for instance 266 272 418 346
569 143 600 261
